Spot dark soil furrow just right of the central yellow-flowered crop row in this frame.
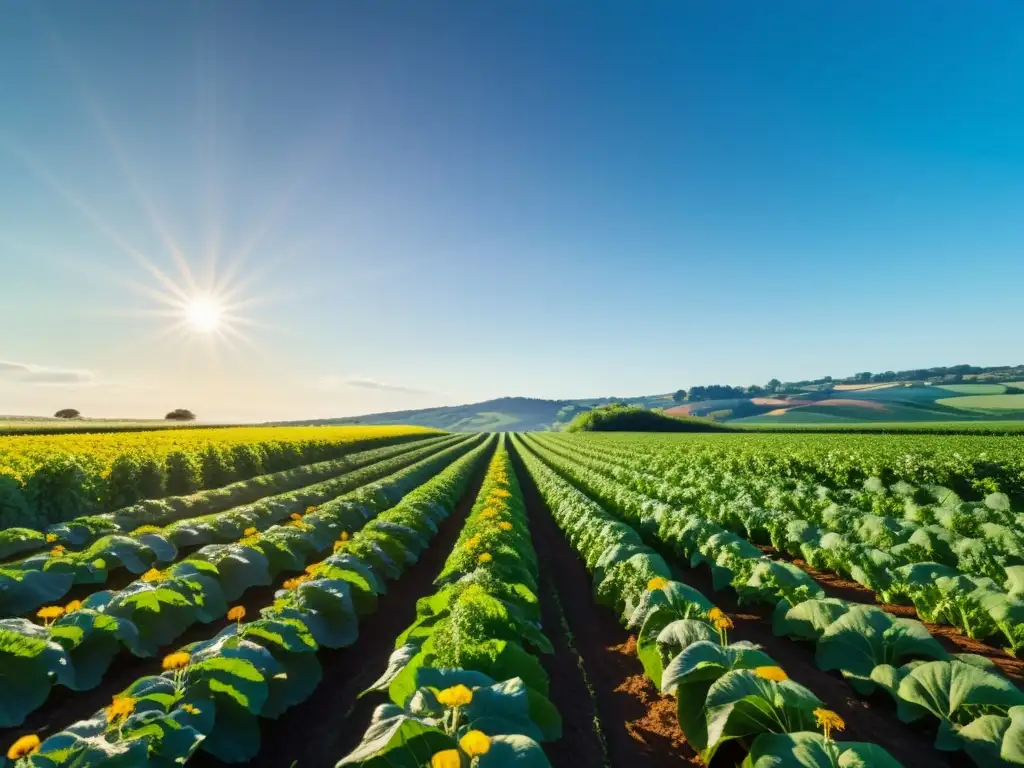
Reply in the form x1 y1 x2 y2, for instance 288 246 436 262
512 451 696 768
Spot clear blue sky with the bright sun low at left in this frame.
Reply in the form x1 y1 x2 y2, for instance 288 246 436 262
0 0 1024 420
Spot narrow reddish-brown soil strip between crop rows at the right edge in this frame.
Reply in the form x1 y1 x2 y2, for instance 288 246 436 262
760 546 1024 683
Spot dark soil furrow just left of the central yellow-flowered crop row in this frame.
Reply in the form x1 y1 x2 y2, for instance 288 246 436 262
209 450 486 768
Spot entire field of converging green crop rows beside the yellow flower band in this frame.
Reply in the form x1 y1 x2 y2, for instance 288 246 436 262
0 427 1024 768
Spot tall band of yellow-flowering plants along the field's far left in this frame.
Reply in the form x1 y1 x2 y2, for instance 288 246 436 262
0 426 432 528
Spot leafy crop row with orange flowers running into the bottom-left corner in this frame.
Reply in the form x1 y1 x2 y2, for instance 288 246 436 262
0 440 492 768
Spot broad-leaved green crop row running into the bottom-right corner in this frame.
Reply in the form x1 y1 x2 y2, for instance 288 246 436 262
530 440 1024 766
